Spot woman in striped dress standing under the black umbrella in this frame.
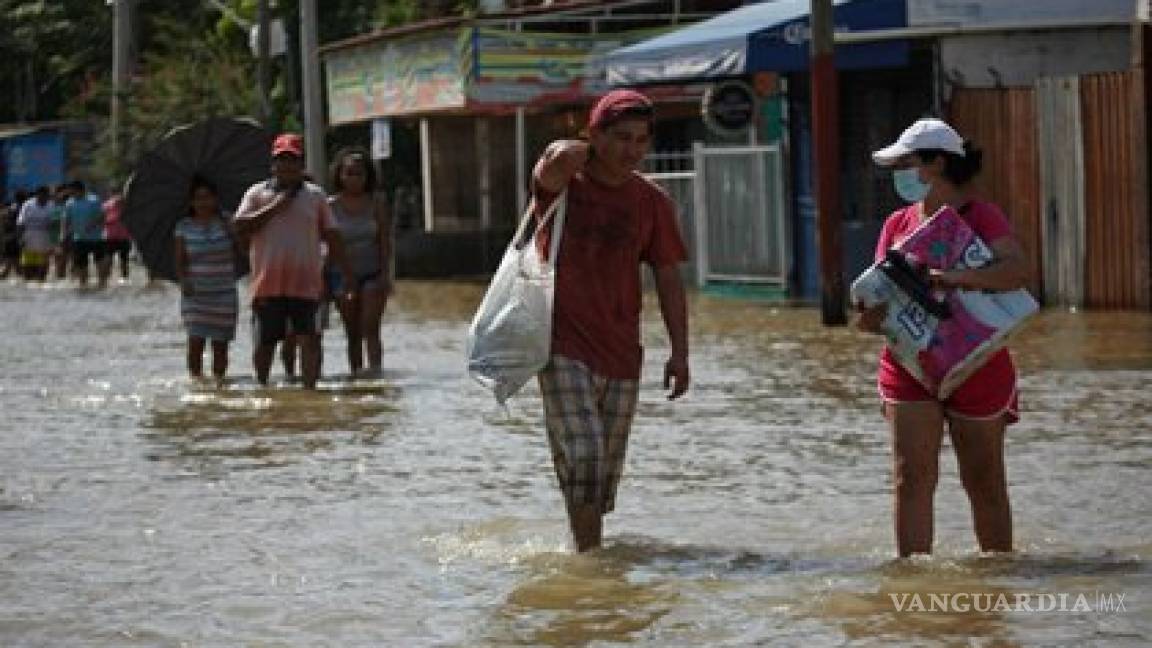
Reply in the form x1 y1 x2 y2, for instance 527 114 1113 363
174 175 240 382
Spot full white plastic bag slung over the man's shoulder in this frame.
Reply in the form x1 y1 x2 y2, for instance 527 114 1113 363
468 194 567 405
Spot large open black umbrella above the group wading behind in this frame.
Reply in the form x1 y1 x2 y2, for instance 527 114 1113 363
122 118 273 279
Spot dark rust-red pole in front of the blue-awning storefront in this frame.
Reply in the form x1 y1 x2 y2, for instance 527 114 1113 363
811 0 848 326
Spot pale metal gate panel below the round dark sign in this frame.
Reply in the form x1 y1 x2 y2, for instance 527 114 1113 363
692 143 789 287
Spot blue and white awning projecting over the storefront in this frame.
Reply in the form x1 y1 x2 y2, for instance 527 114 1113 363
605 0 908 85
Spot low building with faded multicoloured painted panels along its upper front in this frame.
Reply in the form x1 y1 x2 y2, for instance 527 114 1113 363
324 21 698 273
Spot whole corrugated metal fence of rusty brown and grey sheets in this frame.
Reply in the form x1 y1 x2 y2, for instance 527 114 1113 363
949 70 1152 310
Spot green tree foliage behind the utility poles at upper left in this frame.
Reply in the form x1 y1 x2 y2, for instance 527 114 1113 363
0 0 477 178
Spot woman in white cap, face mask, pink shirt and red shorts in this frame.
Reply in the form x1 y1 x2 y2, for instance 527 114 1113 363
857 119 1028 557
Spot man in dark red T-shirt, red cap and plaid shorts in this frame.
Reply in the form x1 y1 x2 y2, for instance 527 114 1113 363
532 90 689 551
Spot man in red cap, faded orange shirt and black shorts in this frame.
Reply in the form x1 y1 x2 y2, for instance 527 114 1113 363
236 133 355 389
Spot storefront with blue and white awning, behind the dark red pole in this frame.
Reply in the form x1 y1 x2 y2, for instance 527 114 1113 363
606 0 916 299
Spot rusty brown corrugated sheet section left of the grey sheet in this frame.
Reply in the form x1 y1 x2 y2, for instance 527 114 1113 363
949 88 1044 295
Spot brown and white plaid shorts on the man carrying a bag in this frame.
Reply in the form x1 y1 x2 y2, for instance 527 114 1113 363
539 355 639 513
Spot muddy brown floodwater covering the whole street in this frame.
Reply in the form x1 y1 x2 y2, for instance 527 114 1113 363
0 273 1152 648
